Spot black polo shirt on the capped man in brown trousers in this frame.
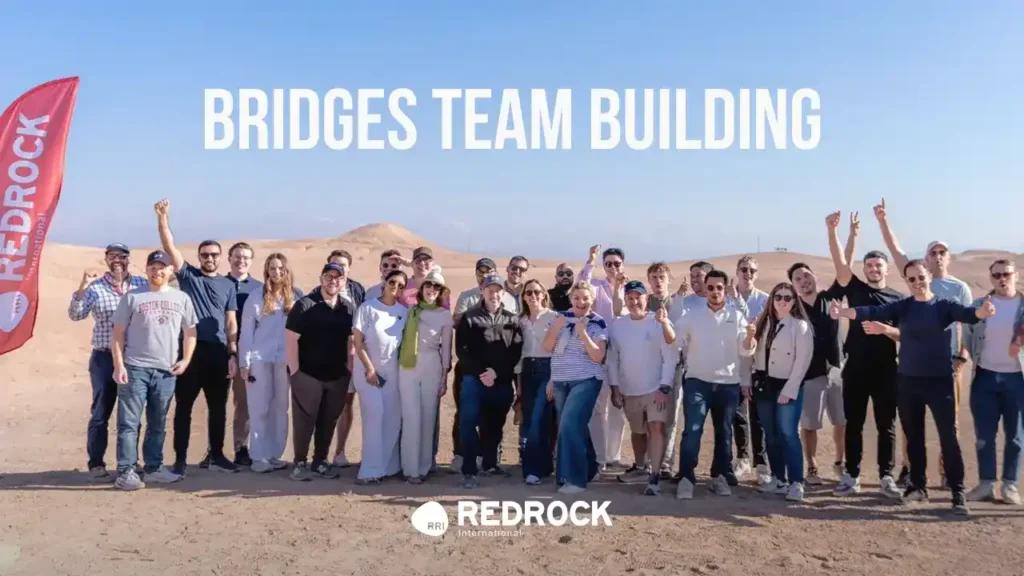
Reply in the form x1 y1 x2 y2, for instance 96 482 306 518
285 290 355 382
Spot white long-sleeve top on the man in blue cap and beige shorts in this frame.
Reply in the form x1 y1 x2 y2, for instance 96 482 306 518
608 314 679 396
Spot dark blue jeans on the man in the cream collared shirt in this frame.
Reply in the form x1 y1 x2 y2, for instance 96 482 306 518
679 378 739 483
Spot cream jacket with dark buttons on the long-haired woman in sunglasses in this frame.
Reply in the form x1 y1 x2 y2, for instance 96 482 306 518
743 317 814 398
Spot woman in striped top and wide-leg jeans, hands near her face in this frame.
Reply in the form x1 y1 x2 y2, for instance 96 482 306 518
544 282 608 494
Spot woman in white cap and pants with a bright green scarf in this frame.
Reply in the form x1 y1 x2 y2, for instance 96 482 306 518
398 270 453 484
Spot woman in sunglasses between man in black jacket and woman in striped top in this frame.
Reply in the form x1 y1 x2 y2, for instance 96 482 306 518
516 280 560 485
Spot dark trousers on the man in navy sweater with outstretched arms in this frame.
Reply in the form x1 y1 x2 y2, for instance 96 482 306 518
897 374 964 492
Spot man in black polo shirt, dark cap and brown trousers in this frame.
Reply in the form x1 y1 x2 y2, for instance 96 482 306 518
285 263 356 482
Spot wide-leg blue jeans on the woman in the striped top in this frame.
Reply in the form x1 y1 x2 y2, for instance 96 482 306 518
554 378 601 488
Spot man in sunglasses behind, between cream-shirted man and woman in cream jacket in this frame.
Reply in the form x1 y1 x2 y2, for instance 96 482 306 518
729 256 771 486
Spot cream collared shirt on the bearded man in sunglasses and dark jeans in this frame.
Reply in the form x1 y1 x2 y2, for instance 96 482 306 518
675 305 754 384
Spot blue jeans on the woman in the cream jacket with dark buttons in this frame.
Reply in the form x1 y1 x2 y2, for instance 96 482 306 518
757 385 804 483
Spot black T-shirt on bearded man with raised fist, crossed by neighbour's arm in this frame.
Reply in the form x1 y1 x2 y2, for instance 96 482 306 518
829 275 905 372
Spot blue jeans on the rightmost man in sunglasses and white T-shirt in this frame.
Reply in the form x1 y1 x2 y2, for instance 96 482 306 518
971 368 1024 483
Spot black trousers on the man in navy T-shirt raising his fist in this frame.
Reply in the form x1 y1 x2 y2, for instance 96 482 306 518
174 341 231 462
